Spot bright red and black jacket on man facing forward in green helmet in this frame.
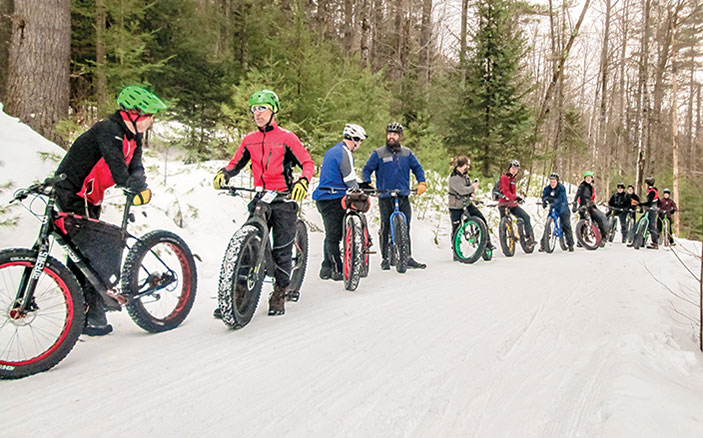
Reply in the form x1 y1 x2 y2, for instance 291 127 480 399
225 122 315 191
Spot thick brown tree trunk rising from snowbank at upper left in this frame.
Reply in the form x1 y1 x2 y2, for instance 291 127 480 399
6 0 71 147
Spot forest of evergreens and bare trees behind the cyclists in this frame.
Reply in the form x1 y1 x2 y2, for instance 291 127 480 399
0 0 703 239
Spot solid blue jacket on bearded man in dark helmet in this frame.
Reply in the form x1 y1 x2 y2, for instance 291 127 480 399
361 146 425 198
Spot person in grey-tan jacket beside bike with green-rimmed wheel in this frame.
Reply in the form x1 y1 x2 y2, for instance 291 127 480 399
448 155 495 260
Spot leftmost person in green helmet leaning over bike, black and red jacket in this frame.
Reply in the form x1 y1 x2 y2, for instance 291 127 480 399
55 85 166 336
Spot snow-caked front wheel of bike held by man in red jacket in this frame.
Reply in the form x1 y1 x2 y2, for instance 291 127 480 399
217 225 264 330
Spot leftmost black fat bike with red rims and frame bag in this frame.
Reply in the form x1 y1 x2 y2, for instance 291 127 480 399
0 174 197 379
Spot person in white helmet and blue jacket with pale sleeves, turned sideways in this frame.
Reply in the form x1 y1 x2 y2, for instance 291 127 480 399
312 123 366 281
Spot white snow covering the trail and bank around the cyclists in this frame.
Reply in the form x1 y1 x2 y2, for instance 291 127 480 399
0 107 703 438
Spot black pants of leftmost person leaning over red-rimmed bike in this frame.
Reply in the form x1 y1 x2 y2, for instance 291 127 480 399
56 188 107 326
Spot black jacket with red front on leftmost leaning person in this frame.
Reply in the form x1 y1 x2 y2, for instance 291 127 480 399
56 111 146 205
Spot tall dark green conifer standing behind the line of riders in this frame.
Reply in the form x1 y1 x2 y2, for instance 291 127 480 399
447 0 534 175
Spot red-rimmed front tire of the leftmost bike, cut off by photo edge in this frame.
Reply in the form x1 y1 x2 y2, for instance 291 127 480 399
0 248 85 379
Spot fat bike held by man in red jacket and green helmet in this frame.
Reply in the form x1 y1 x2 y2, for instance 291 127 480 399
217 187 308 330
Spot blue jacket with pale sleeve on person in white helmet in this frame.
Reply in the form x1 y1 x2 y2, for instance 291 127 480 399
312 142 359 201
